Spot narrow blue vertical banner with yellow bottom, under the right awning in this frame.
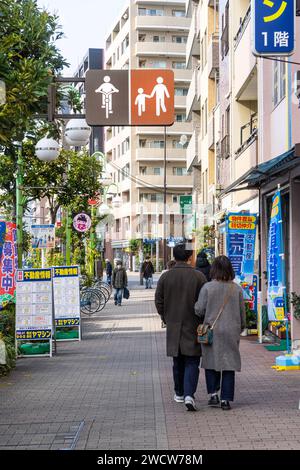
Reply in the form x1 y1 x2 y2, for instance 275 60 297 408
267 191 285 321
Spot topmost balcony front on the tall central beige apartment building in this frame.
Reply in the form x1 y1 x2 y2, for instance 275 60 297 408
135 16 191 31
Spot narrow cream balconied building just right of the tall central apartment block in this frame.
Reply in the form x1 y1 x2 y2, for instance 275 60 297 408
186 0 219 235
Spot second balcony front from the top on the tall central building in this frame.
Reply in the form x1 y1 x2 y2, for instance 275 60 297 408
135 41 186 58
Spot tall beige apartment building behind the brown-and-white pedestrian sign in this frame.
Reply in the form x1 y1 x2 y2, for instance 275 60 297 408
105 0 193 264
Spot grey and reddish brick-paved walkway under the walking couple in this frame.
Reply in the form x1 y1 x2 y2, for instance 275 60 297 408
0 277 300 450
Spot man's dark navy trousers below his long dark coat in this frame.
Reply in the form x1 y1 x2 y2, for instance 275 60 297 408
173 352 200 398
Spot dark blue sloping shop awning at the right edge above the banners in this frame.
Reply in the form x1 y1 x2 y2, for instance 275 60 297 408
220 148 300 197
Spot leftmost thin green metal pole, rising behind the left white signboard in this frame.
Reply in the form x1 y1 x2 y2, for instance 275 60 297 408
16 151 24 269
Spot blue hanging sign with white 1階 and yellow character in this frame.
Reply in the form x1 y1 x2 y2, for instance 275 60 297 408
252 0 296 56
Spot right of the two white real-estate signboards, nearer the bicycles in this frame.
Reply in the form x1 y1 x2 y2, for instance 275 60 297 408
53 266 81 341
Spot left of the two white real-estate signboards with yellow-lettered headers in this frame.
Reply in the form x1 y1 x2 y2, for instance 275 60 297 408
16 269 53 356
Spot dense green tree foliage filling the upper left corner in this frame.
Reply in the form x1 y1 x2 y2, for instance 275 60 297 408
0 0 67 148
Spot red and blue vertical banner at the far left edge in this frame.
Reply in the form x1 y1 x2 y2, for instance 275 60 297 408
0 222 17 309
